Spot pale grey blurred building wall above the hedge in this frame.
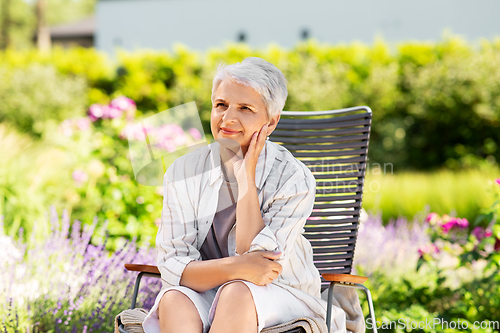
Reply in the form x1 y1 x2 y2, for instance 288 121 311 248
96 0 500 52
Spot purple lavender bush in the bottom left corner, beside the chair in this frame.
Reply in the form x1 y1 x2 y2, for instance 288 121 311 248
0 209 160 332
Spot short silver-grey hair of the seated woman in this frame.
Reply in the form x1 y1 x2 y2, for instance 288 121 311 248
212 57 288 117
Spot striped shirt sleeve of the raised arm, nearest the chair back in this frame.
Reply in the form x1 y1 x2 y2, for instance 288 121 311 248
247 166 316 260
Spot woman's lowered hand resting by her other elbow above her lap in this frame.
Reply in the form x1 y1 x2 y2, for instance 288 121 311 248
236 251 283 286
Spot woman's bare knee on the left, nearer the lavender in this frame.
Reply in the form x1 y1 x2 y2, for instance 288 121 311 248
158 290 203 333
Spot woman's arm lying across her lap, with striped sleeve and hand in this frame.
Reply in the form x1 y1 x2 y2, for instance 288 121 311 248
156 152 282 292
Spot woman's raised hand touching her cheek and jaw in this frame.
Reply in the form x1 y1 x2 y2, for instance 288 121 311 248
233 124 268 184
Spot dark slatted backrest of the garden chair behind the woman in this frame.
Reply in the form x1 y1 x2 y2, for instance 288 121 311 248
270 106 372 287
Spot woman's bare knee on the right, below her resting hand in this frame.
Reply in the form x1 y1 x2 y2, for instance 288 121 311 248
210 281 257 333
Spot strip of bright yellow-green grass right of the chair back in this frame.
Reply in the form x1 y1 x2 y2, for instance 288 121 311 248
363 169 500 222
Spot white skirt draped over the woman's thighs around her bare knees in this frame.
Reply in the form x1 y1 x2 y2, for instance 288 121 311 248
142 280 334 333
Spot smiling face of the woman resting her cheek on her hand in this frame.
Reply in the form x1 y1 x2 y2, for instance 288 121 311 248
210 79 279 154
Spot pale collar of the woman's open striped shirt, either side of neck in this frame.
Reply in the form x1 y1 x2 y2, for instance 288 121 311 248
208 140 276 189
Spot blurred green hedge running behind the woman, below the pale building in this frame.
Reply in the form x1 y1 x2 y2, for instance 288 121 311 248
0 38 500 171
